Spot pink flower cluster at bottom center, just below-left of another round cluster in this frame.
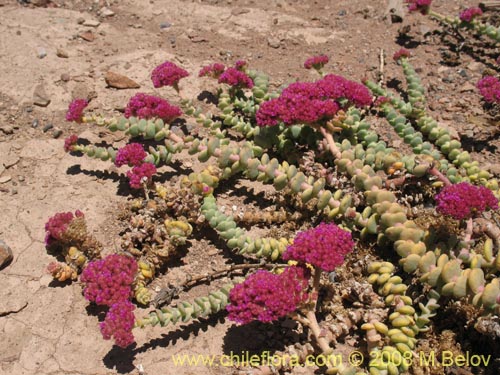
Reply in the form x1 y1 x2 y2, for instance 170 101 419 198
226 267 310 324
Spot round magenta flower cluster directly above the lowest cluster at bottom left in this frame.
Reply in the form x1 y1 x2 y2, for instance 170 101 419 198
81 254 138 306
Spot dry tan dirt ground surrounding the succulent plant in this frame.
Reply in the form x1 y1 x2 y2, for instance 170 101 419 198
0 0 499 375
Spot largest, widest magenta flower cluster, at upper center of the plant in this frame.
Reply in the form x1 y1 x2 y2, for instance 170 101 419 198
256 74 372 126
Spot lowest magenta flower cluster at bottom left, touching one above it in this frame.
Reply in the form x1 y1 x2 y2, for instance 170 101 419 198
100 300 135 348
